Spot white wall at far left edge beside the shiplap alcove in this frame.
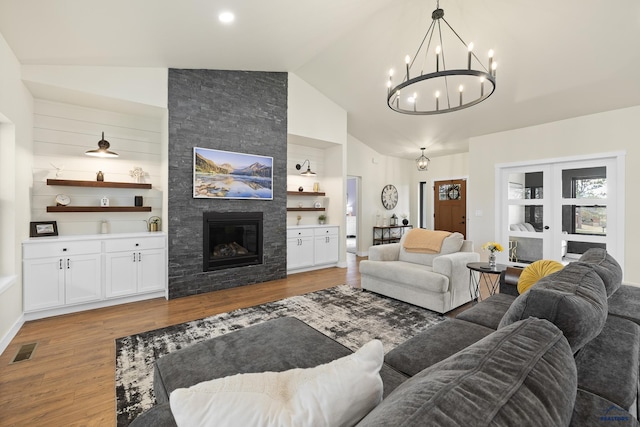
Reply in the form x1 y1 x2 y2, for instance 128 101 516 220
0 31 33 352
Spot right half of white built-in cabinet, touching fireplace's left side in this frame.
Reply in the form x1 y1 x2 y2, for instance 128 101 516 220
105 237 165 298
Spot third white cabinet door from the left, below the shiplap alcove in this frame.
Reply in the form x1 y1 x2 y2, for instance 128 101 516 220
105 251 138 298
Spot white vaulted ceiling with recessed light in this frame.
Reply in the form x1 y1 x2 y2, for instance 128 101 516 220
0 0 640 159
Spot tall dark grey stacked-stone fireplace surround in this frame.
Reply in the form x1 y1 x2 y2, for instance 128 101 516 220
168 69 287 298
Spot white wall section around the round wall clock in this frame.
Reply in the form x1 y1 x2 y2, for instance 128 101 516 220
347 135 417 256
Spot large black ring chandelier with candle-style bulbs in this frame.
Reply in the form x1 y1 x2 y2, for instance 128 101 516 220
387 0 497 115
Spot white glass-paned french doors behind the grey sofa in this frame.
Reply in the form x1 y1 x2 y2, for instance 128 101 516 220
497 155 624 264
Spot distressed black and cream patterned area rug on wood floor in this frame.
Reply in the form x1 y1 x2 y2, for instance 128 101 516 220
116 285 445 426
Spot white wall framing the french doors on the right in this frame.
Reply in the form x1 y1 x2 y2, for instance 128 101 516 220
468 106 640 285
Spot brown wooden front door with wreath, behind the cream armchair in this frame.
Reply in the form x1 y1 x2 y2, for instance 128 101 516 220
433 179 467 238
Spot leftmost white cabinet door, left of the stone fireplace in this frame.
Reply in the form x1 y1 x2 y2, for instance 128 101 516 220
24 258 64 311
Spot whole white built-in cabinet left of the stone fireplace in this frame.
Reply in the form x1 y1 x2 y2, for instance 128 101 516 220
22 233 167 320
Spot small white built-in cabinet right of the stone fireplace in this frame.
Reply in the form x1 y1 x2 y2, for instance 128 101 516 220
287 225 340 272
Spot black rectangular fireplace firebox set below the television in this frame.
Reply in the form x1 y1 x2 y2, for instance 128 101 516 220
202 212 262 271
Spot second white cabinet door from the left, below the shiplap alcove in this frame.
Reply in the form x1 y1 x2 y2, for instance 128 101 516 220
63 254 102 304
